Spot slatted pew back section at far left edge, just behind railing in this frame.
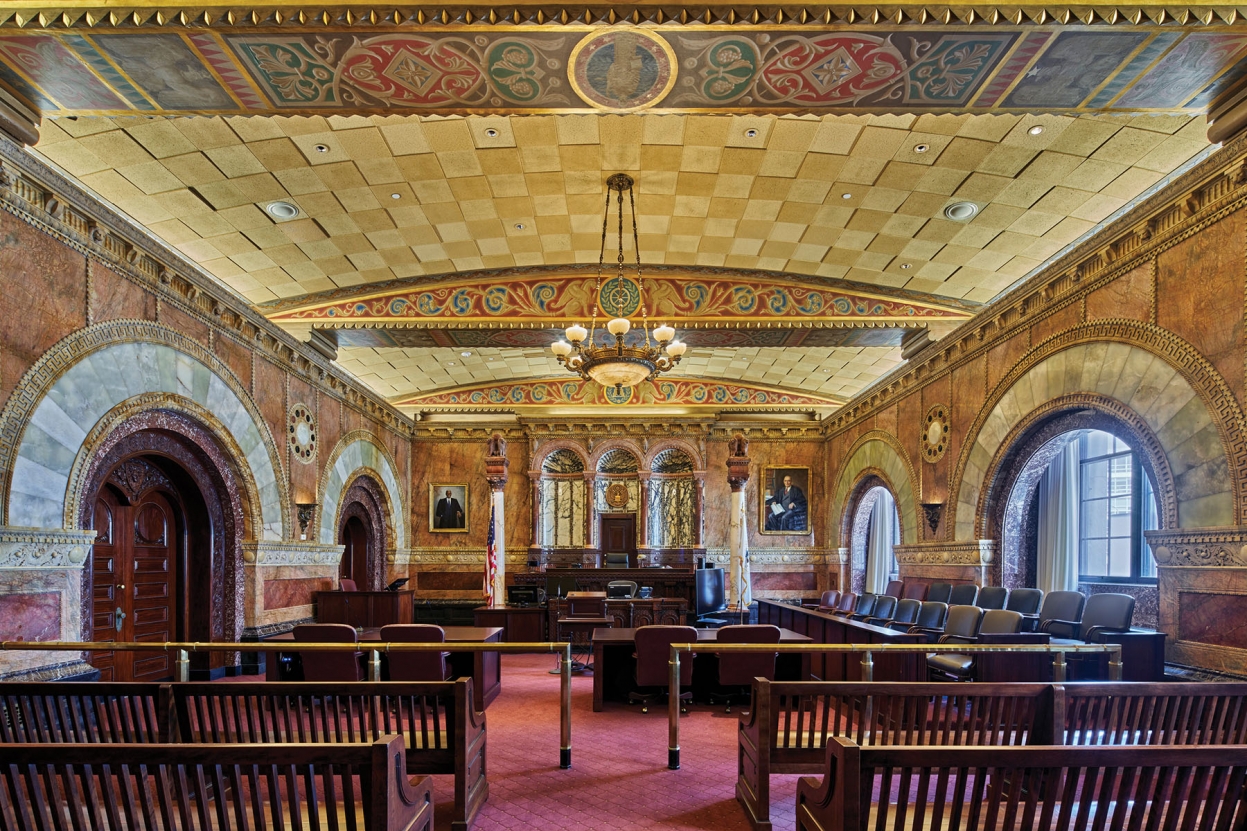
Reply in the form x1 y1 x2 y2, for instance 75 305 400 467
0 681 172 744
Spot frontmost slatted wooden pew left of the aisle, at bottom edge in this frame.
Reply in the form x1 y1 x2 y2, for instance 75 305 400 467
0 735 433 831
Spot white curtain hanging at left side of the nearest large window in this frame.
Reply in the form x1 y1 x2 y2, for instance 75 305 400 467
1035 438 1081 594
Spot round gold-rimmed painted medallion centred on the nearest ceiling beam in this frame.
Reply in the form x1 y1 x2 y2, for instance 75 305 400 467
567 29 676 110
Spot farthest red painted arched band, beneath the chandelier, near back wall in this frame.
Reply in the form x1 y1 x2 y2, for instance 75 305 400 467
390 378 844 409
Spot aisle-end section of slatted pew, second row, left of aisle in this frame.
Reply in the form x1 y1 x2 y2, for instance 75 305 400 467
173 678 489 831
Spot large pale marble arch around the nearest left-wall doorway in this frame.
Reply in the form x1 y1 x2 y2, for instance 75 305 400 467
0 321 289 540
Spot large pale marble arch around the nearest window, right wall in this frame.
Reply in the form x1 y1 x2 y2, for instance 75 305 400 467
949 321 1247 542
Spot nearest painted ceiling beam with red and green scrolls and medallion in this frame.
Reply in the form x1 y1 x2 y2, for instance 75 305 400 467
0 25 1247 115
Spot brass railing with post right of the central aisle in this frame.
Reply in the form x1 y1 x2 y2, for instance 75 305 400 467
667 641 1121 770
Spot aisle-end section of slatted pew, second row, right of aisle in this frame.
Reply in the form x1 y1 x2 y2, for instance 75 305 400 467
736 679 1052 831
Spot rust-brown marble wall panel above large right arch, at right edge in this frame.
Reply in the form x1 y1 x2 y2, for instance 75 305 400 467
1156 211 1247 407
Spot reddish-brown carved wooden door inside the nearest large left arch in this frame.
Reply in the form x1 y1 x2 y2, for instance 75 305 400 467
91 488 177 681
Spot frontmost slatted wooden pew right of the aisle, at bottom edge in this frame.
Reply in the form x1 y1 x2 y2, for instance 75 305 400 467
797 737 1247 831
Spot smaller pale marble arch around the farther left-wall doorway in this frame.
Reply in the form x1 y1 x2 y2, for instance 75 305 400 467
317 430 408 553
